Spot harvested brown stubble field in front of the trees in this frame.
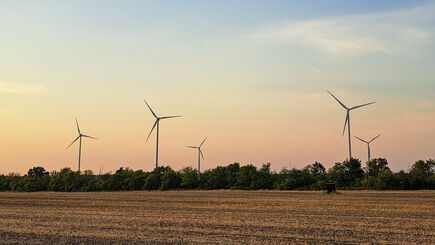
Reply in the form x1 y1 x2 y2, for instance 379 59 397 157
0 191 435 244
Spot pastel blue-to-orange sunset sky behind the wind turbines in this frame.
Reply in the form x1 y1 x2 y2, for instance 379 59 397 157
0 0 435 174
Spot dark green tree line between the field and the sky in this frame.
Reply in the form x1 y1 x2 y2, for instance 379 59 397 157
0 158 435 192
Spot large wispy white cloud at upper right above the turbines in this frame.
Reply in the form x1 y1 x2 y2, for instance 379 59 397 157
250 4 435 55
